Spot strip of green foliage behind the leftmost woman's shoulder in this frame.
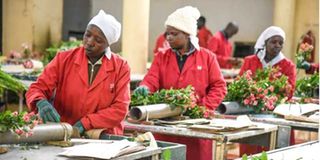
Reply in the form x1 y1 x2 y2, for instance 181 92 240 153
42 40 82 65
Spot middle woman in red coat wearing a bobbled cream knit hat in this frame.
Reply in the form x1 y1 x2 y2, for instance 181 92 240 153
135 6 226 160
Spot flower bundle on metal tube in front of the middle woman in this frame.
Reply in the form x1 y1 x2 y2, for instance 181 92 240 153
130 85 211 118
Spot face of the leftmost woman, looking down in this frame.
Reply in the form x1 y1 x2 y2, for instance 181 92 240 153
83 25 109 58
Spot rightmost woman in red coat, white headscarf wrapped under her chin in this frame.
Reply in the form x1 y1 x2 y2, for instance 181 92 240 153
239 26 296 156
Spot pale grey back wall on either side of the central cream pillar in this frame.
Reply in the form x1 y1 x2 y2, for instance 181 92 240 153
91 0 273 59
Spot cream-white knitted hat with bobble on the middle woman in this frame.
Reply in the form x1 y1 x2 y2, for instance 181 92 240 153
165 6 200 50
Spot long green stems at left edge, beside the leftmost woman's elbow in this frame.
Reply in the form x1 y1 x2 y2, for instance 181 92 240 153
0 70 27 94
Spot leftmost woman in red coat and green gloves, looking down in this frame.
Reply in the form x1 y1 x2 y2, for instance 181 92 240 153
26 10 130 135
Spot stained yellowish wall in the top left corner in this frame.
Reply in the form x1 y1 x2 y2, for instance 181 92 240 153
2 0 62 55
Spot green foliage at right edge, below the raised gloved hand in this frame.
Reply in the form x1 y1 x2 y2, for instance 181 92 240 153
295 73 319 102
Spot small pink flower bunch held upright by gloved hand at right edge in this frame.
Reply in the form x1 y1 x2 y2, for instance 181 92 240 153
296 43 313 66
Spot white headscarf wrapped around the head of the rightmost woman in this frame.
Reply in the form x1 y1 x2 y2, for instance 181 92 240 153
254 26 286 68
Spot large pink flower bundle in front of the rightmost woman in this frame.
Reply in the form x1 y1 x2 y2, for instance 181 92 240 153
225 67 292 113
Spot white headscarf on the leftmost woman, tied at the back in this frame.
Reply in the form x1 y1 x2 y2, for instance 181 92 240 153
88 10 121 59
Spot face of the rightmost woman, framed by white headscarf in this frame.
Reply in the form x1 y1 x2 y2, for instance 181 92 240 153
265 36 283 57
